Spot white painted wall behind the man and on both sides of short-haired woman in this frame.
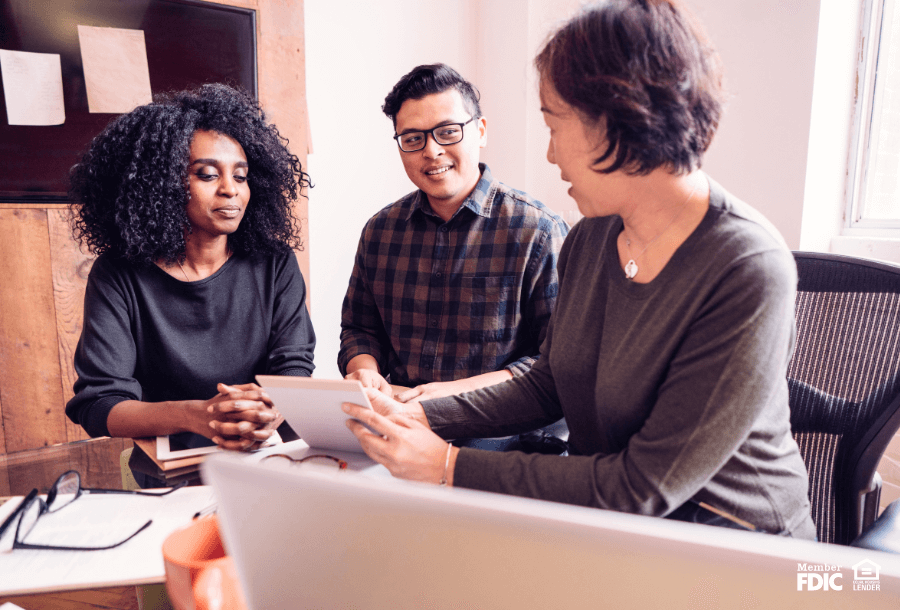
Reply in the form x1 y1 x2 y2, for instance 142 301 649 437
305 0 828 377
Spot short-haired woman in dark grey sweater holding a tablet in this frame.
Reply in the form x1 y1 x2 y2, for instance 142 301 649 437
346 0 816 539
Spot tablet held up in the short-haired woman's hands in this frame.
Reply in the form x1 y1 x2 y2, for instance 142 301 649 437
256 375 372 453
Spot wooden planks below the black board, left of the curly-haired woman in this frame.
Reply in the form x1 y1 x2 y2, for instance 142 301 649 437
0 204 92 453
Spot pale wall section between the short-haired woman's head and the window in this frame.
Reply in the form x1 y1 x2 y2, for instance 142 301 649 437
689 0 824 249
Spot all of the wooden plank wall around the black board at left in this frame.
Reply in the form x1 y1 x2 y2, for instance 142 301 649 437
0 0 310 456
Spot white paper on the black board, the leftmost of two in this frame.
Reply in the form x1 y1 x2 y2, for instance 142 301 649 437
0 49 66 125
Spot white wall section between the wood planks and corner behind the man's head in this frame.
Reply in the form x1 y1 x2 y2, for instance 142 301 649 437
304 0 477 379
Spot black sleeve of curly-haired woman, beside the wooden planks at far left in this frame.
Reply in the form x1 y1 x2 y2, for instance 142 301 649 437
66 257 142 437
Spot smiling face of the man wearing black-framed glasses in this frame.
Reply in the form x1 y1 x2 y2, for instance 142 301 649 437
396 89 487 214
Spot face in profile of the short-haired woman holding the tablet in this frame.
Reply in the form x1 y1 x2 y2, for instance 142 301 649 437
541 79 629 217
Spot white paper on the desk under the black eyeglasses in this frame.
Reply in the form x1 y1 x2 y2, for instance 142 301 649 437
0 486 215 595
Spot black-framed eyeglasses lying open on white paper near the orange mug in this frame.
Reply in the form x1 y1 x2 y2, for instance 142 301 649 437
6 470 186 551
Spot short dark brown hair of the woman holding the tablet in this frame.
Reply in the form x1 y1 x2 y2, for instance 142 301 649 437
535 0 725 175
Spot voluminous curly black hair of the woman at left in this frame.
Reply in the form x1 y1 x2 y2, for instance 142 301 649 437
69 84 311 264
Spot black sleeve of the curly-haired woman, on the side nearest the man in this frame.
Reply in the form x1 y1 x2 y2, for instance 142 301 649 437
266 252 316 377
